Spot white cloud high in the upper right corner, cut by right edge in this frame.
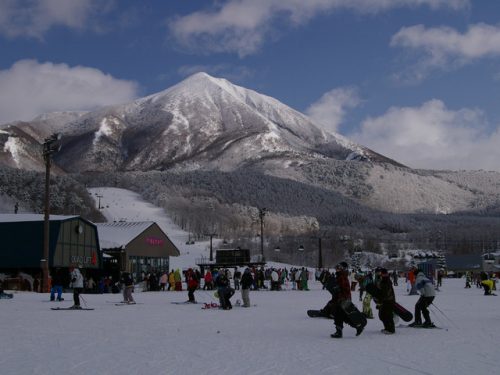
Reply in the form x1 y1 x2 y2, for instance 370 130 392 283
391 23 500 80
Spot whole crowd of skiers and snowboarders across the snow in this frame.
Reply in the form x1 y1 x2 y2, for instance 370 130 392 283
35 262 496 332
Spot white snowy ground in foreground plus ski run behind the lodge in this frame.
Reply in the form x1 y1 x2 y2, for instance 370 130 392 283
0 189 500 375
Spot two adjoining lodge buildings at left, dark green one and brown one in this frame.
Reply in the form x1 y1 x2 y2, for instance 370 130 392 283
0 214 180 288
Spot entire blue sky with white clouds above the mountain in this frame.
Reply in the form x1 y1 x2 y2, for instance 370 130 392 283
0 0 500 171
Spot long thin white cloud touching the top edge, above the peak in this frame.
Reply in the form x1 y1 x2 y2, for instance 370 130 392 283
169 0 470 56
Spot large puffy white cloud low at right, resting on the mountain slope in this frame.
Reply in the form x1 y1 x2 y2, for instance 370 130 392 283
348 100 500 171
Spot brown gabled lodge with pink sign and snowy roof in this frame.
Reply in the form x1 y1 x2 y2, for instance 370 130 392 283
96 221 180 280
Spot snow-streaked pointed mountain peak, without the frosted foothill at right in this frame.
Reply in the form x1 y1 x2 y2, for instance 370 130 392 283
0 73 398 172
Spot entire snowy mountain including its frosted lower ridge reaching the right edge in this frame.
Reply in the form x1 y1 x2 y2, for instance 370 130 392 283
0 73 500 217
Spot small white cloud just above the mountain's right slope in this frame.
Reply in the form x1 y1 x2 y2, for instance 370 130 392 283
306 87 360 133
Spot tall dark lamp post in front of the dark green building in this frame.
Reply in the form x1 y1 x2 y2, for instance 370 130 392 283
40 133 61 292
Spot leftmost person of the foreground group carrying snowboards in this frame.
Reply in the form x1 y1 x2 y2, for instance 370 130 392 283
327 262 364 339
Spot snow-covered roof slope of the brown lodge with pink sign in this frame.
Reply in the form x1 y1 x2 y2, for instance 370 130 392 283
96 221 159 249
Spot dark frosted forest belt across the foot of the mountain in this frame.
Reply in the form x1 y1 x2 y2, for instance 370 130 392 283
0 168 500 257
